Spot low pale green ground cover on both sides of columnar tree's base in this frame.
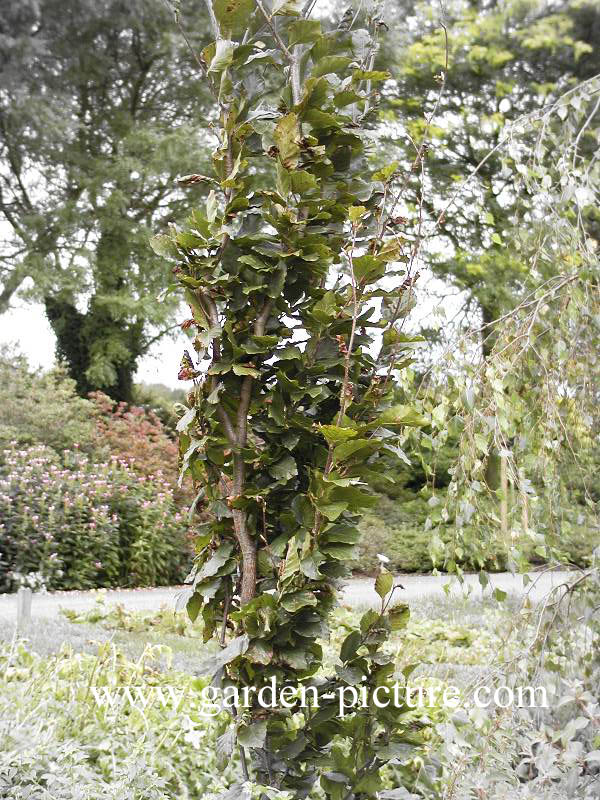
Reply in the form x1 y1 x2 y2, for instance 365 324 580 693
0 579 600 800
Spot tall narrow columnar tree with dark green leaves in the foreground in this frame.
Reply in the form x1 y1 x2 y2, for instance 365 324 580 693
152 0 423 800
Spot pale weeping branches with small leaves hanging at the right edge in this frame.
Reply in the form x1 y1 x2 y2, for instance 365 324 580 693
420 72 599 576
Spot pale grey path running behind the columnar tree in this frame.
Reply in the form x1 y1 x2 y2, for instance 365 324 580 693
0 572 577 626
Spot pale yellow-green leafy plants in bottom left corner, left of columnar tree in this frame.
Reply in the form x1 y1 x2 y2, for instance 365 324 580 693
0 642 235 800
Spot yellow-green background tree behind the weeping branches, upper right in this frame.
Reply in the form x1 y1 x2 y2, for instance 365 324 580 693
381 0 600 355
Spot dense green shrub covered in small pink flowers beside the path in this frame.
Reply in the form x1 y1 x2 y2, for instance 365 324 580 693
0 445 189 591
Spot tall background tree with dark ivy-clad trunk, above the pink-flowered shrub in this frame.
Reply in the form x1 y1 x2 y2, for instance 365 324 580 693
0 0 210 400
